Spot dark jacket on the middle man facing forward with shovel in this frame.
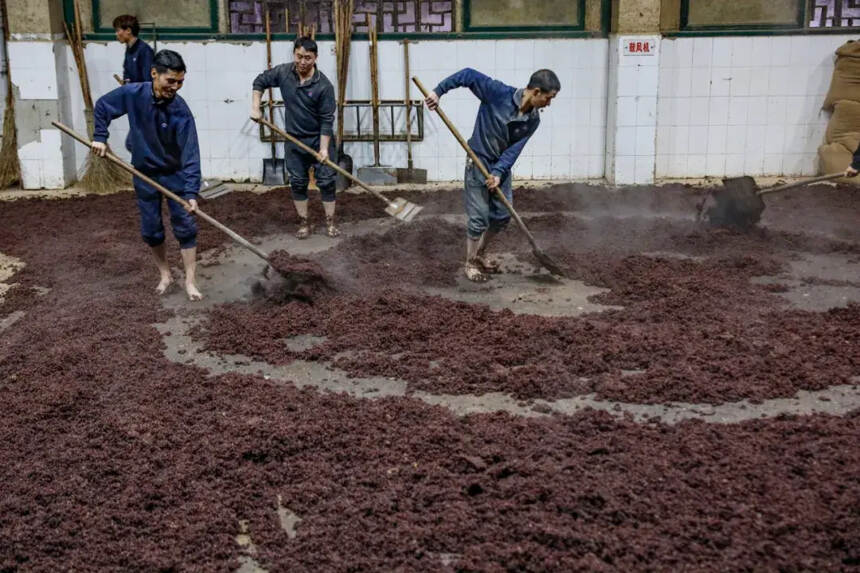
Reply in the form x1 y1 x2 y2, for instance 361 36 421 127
254 64 337 140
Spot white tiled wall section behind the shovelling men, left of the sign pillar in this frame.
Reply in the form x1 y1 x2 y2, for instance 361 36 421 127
73 39 608 181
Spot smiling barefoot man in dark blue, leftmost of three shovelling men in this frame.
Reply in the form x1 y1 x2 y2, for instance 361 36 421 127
92 50 202 300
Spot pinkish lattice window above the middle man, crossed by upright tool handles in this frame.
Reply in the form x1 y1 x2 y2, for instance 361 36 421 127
229 0 454 34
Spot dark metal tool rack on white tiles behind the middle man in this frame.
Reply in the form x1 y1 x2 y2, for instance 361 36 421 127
260 99 424 143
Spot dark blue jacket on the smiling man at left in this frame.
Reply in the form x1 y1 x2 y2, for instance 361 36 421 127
93 82 200 198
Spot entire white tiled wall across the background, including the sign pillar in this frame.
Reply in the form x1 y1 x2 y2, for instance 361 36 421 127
9 35 851 187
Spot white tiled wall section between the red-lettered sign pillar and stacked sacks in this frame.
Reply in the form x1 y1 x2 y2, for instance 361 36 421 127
656 35 854 177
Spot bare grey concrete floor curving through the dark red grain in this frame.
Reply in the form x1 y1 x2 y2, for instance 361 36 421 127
149 213 860 424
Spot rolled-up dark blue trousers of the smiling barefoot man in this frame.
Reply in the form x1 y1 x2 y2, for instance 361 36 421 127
134 173 197 249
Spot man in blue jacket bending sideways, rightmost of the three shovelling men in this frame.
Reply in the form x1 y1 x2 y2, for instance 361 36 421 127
426 68 561 282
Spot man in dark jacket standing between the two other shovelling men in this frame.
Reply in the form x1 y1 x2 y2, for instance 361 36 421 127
251 38 340 239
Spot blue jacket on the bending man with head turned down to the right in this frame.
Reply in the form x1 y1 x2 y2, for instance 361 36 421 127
433 68 540 179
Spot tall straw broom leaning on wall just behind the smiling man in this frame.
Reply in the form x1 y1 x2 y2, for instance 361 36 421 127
63 0 131 194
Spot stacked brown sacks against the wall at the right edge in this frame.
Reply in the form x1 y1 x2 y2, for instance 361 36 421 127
818 40 860 183
